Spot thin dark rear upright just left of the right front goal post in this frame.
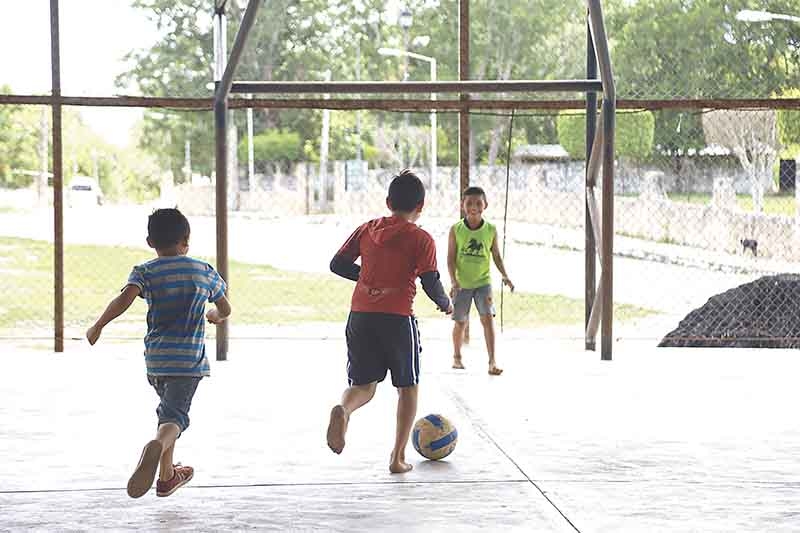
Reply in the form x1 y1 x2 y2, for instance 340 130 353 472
584 20 597 351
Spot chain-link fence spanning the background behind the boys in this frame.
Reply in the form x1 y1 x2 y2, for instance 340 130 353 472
0 1 800 346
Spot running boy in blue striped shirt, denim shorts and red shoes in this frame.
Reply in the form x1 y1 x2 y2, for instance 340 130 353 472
86 209 231 498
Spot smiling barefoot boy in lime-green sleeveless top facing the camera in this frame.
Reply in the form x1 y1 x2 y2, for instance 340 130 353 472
447 187 514 376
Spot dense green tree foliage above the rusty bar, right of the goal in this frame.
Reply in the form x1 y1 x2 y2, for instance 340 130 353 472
607 0 800 98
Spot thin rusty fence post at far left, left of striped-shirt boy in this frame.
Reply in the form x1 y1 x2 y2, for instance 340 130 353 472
50 0 64 352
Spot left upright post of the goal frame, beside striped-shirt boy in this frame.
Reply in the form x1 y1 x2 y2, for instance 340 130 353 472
214 7 230 361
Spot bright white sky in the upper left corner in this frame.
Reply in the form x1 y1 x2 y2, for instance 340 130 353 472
0 0 158 146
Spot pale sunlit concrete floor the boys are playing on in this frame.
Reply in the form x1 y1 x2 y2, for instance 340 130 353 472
0 338 800 532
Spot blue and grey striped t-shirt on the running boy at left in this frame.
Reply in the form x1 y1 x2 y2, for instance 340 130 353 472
128 255 225 377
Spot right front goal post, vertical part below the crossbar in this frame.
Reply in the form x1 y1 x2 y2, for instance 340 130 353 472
600 98 617 361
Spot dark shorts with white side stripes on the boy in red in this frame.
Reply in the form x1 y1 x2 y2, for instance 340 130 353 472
346 311 422 387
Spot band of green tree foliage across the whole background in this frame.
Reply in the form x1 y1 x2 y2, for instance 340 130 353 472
6 0 800 200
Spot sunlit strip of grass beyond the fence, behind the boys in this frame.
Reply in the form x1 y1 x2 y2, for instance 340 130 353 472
0 238 654 330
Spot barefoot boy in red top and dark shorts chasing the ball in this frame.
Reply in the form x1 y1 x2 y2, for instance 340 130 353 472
327 170 453 474
